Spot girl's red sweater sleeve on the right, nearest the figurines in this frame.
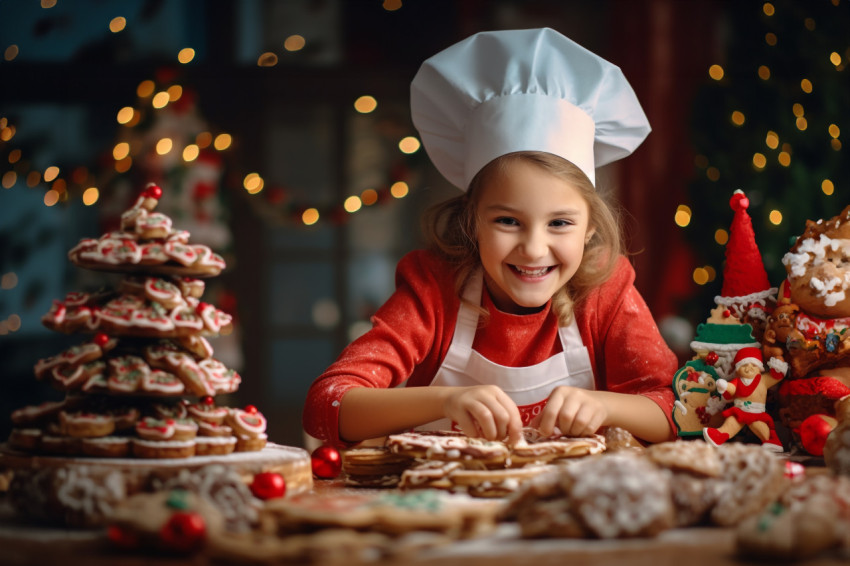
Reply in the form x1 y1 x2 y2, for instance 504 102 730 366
576 257 678 440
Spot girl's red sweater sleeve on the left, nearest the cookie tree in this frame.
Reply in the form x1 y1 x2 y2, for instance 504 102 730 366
302 250 459 446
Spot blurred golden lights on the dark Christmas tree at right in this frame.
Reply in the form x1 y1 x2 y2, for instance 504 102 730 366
673 0 850 285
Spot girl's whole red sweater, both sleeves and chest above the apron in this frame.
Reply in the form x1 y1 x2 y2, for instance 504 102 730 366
303 250 678 446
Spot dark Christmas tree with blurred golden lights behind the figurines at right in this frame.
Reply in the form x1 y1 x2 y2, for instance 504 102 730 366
679 0 850 310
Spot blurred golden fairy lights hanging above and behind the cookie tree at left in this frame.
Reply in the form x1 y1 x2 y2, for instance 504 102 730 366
0 0 421 226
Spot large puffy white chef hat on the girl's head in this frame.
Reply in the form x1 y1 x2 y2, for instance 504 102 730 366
410 28 650 190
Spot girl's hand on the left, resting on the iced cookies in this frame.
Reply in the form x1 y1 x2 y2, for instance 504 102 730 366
443 385 522 445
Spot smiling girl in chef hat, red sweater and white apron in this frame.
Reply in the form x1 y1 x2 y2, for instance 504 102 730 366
304 29 677 446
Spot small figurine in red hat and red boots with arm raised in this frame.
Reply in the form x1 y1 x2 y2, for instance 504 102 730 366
702 347 788 452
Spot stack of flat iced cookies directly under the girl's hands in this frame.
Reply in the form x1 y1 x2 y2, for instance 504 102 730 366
343 428 606 497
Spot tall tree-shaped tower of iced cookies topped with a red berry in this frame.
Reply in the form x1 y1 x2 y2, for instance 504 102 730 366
8 184 266 458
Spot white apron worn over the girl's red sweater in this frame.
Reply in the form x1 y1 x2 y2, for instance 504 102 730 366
417 272 595 430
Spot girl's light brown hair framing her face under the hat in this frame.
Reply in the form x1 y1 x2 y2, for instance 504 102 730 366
423 151 623 325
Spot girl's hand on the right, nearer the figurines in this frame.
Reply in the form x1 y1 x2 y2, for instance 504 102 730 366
538 386 608 436
